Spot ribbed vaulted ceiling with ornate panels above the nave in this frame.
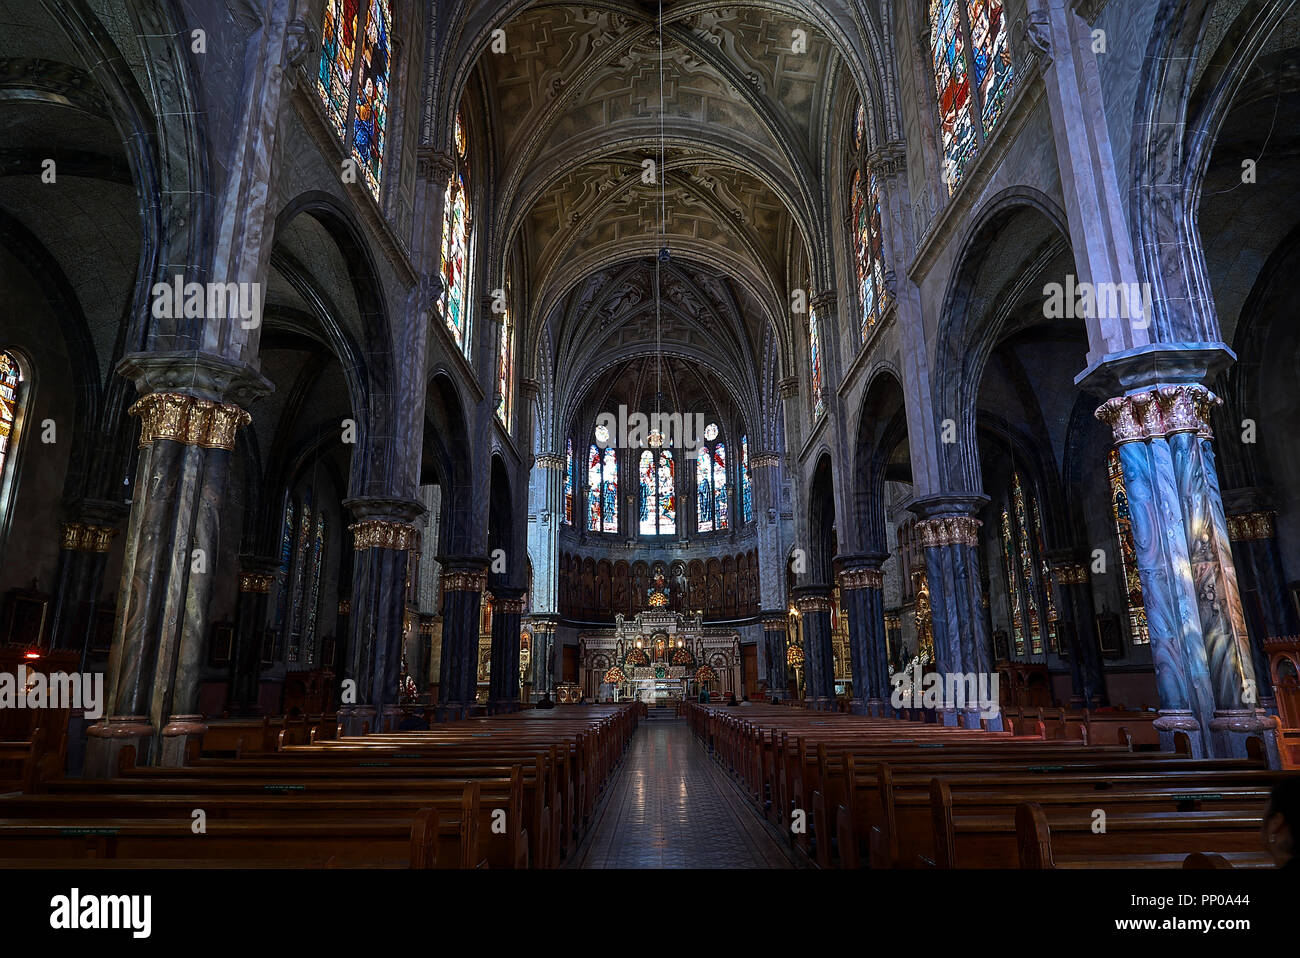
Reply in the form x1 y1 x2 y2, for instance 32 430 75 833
460 0 883 441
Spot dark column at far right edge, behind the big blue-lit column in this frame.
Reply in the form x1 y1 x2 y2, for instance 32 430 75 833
1227 510 1300 715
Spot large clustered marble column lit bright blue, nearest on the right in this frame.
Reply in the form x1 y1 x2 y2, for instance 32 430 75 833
1097 383 1277 760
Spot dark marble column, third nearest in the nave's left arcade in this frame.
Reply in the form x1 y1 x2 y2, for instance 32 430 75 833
437 556 488 721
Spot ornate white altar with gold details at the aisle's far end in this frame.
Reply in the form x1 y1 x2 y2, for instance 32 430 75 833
579 607 741 705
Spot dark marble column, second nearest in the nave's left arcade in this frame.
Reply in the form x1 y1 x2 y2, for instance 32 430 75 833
338 498 424 734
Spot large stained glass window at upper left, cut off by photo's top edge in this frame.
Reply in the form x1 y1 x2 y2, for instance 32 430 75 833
316 0 393 199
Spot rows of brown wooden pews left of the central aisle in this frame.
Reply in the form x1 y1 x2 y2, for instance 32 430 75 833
0 706 644 868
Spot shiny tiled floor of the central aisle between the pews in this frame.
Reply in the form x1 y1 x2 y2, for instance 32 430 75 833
568 721 802 868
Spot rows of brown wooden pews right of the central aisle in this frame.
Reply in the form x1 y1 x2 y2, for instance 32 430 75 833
684 703 1296 868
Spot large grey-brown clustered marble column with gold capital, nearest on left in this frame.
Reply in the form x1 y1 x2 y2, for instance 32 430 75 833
86 363 269 777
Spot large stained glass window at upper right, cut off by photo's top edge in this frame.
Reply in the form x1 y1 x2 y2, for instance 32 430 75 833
930 0 1013 192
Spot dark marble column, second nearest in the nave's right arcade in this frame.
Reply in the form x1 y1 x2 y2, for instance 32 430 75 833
909 493 1002 731
